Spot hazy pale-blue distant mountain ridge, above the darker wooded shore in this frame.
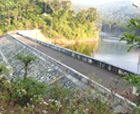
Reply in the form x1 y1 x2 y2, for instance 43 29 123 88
72 0 140 22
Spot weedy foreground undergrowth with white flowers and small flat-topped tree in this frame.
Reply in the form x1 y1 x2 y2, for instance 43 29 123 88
0 55 112 114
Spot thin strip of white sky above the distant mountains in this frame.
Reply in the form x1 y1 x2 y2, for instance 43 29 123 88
71 0 140 5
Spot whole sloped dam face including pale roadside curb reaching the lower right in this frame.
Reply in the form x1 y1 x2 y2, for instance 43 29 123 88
0 35 135 110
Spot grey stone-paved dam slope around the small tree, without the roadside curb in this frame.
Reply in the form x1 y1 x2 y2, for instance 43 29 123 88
0 36 84 89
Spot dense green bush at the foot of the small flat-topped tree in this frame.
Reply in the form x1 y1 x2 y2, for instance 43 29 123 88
9 78 47 105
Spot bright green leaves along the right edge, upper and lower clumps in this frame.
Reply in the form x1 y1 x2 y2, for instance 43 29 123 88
120 14 140 106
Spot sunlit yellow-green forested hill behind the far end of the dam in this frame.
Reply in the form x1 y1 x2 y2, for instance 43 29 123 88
0 0 98 40
